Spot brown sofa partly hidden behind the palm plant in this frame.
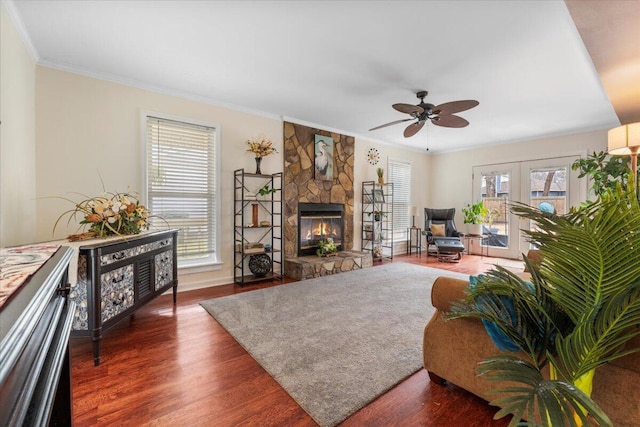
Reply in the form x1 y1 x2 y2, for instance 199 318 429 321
423 277 640 427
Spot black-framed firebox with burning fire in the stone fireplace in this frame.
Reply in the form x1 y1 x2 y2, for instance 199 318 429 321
298 203 344 256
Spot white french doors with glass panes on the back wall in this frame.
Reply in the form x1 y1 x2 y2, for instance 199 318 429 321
473 156 587 259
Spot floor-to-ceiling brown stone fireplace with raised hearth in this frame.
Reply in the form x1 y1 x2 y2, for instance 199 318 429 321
283 122 372 280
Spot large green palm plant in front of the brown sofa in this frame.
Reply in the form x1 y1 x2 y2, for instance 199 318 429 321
449 186 640 426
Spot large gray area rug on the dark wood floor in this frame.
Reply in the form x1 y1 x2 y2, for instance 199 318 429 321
201 262 468 427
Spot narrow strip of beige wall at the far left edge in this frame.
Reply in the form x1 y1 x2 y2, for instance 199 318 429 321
0 3 36 246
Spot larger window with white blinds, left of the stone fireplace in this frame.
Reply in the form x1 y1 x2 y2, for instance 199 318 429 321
145 115 219 267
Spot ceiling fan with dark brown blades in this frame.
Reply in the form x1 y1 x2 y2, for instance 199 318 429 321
369 90 480 138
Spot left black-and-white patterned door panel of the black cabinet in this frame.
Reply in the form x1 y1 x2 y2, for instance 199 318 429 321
100 264 134 323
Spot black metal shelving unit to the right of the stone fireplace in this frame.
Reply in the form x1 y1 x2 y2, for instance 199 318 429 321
360 181 393 261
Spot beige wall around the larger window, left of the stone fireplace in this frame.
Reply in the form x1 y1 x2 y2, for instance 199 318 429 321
36 66 282 289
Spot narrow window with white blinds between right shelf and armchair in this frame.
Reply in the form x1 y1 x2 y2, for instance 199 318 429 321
389 159 411 240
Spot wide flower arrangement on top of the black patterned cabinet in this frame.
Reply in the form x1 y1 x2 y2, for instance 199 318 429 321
53 193 149 241
